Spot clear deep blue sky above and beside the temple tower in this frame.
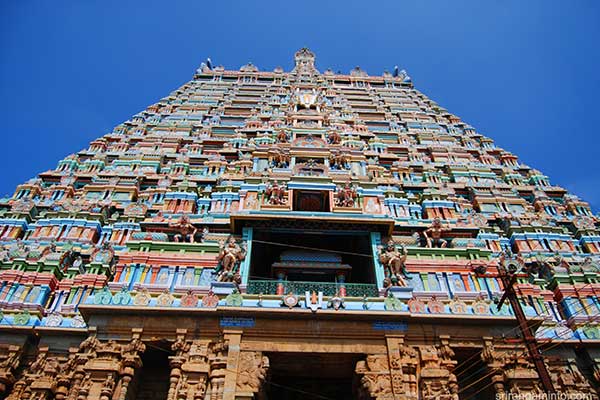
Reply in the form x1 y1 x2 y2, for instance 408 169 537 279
0 0 600 211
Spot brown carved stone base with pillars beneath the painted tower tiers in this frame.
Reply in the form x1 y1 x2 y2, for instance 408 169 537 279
0 307 600 400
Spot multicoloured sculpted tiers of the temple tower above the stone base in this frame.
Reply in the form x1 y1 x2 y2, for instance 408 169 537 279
0 49 600 374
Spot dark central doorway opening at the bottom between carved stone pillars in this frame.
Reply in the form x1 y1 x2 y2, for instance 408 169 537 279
264 353 364 400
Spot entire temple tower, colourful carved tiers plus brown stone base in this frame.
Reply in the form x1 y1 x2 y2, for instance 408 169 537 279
0 48 600 400
